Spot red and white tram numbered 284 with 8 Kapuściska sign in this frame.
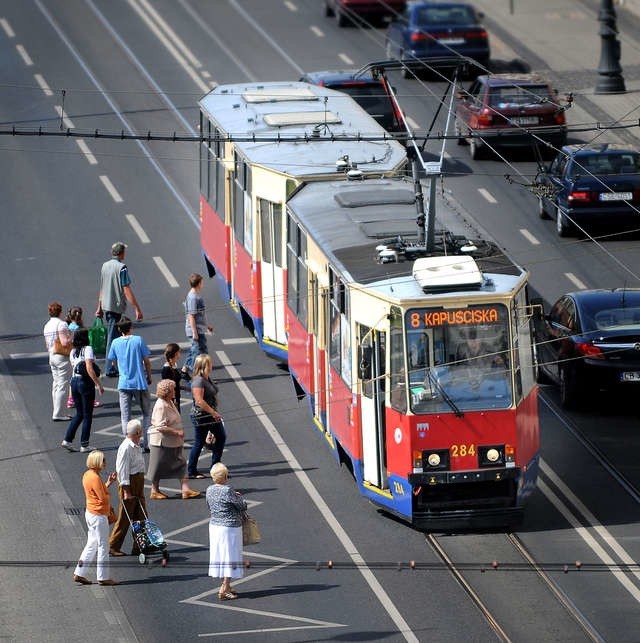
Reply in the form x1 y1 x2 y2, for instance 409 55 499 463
201 79 539 530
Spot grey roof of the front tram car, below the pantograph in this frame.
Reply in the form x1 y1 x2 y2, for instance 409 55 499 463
287 178 526 299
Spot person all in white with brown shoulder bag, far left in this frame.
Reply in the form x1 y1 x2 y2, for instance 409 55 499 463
43 301 71 422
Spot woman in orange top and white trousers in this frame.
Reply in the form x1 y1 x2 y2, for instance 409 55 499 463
73 450 118 585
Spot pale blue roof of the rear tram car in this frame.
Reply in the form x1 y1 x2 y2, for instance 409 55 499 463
199 82 406 177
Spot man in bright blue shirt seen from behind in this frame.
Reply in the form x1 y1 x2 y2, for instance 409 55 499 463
107 317 151 451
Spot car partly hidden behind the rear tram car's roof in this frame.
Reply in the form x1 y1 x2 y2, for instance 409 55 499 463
300 69 406 133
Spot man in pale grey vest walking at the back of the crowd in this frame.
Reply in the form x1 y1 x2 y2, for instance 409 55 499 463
96 241 142 377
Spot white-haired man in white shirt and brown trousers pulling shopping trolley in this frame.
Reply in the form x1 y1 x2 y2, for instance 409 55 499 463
109 420 147 556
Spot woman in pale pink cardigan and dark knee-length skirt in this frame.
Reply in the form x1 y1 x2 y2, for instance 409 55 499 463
147 380 202 500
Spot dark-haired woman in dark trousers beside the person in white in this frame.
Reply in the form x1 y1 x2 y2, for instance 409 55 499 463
60 328 104 453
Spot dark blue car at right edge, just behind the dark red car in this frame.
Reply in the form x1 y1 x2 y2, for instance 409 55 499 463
535 143 640 237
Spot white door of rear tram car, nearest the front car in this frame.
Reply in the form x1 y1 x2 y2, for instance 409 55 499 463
258 199 287 344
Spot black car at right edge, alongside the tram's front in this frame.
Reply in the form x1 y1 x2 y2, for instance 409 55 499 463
532 288 640 408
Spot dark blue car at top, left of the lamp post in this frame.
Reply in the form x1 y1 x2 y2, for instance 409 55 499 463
385 2 490 78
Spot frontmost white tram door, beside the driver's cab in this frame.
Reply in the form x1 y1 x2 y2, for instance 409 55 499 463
358 326 386 488
